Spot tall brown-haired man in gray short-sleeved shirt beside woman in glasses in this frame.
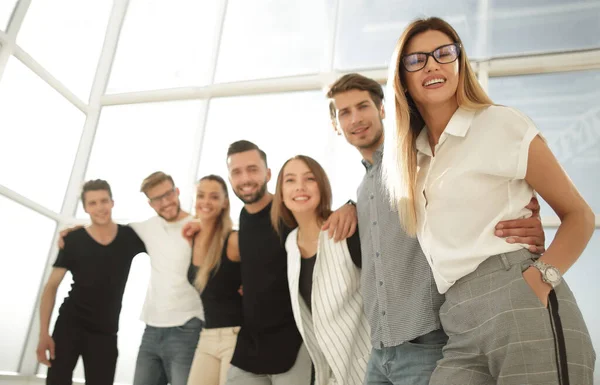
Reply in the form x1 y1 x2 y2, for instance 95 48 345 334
327 74 545 385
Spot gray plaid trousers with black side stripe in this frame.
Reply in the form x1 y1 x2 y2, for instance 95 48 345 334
429 249 596 385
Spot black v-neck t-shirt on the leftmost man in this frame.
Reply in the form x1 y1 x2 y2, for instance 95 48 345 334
54 225 146 334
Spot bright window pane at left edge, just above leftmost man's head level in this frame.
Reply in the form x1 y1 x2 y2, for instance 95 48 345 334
0 58 85 212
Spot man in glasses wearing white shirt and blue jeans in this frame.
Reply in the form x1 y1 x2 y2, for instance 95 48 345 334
130 171 204 385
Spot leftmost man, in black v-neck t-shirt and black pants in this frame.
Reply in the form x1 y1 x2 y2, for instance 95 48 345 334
37 180 145 385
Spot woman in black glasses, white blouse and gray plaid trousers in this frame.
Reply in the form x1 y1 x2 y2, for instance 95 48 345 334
384 18 595 385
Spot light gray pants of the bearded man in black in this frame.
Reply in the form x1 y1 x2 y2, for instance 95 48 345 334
226 344 312 385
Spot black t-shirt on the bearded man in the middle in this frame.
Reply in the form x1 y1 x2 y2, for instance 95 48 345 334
231 203 302 374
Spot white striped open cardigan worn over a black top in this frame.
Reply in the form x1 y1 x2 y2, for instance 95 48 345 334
285 229 371 385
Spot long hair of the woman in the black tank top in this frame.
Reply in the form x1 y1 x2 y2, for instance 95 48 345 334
194 175 233 292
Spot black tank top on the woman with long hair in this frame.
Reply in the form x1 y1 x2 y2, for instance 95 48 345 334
188 233 243 329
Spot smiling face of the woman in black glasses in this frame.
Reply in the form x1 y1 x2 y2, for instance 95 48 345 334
403 30 459 108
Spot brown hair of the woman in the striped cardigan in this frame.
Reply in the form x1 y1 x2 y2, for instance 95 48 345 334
271 155 331 236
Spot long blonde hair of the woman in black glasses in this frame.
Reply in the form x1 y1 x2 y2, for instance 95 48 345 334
382 17 493 236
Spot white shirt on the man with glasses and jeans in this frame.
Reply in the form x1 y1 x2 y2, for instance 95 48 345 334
130 216 204 327
